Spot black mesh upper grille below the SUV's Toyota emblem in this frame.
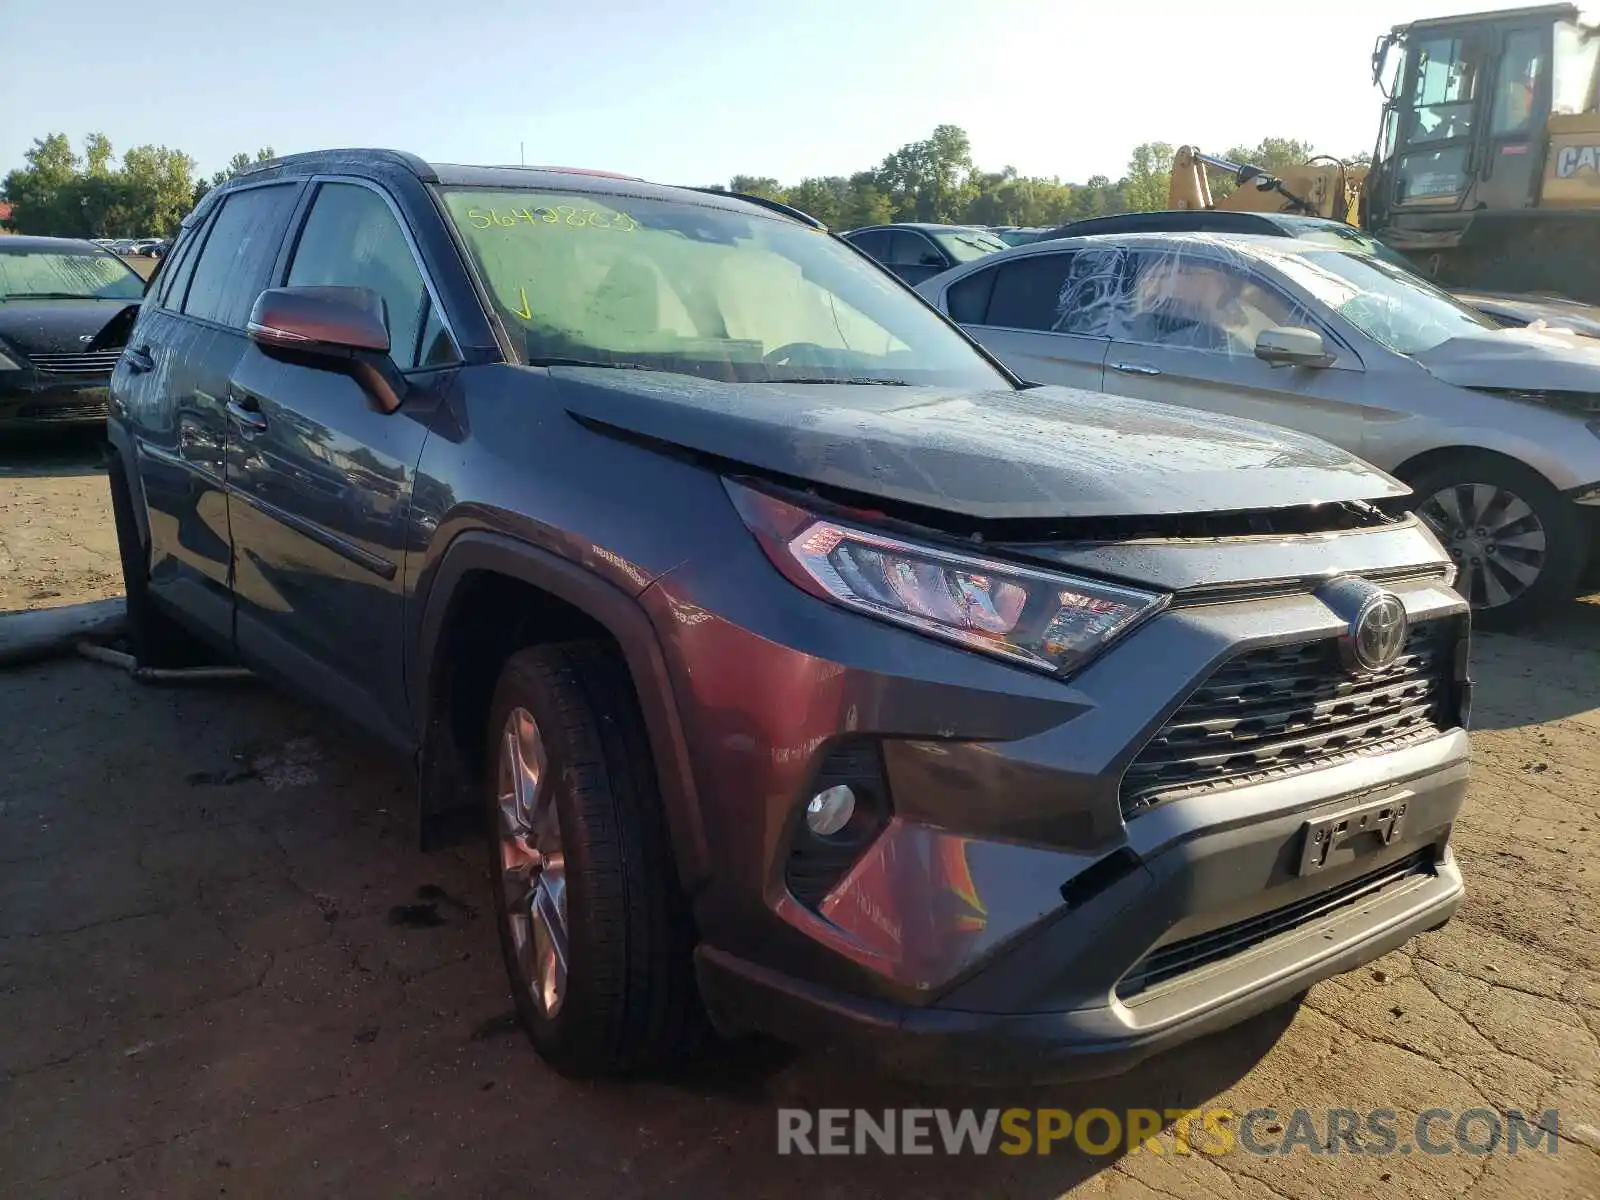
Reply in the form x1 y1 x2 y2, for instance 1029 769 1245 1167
1122 619 1459 816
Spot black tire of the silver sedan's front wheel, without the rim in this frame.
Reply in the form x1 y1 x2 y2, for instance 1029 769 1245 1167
1406 451 1589 632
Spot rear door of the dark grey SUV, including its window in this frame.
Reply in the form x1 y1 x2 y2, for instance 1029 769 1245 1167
115 181 301 642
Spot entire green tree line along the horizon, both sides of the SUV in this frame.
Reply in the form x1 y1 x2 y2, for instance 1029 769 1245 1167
0 125 1337 237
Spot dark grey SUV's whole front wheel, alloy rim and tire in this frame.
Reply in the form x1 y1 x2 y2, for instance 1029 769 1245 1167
485 642 702 1077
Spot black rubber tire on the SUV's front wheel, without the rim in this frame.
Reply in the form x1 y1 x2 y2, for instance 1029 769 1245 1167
485 642 707 1078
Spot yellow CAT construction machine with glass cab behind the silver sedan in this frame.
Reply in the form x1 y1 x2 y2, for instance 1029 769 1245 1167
1170 5 1600 304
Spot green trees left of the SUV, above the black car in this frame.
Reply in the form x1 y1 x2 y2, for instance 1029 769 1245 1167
0 133 274 237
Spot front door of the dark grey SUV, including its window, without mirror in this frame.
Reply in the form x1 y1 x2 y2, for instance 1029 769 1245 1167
227 181 456 741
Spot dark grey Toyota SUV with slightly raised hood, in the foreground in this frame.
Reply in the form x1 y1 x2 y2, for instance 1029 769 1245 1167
109 150 1469 1078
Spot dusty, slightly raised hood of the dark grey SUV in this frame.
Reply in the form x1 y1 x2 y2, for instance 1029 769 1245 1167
550 368 1406 520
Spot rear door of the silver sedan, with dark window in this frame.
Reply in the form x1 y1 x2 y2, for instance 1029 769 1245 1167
944 250 1114 392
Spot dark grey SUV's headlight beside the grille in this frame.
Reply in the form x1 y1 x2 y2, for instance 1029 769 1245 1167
726 482 1166 675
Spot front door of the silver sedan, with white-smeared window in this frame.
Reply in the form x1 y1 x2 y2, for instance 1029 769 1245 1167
1106 250 1366 453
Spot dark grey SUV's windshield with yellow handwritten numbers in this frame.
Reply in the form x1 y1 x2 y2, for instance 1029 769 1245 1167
443 189 1008 387
